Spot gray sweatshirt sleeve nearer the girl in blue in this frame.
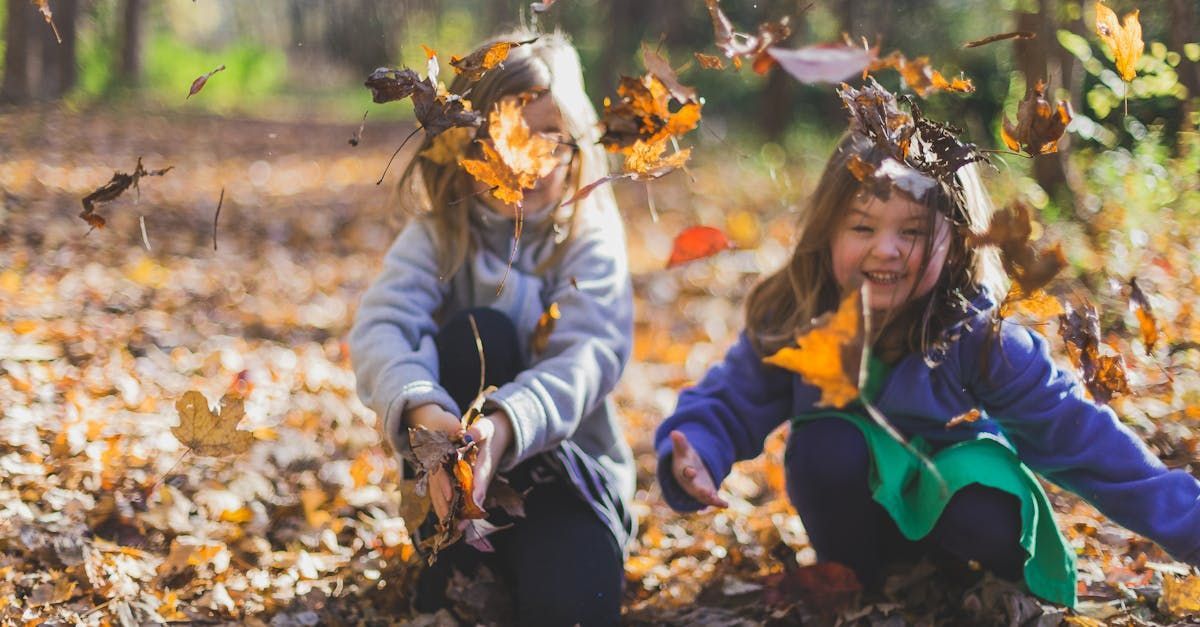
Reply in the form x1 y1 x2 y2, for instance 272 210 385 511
487 208 634 471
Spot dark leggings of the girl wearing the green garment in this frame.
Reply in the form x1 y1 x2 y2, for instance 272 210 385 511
785 418 1025 587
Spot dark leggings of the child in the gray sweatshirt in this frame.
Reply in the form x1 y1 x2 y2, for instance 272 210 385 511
415 309 624 625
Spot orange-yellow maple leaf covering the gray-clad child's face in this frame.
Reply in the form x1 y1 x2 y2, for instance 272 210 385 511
458 98 559 204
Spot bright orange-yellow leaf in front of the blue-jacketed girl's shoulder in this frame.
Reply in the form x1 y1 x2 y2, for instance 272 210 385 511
763 285 869 407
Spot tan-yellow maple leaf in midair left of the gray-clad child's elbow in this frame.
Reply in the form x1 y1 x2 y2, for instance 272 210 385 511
170 390 254 458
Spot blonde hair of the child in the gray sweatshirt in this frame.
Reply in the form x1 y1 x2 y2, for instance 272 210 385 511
398 29 616 280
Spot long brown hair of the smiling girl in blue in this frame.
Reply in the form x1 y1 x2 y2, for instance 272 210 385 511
745 133 1007 362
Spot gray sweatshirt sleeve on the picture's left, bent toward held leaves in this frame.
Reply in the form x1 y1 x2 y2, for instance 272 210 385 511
349 220 461 458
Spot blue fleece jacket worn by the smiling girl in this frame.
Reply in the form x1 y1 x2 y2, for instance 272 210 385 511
655 290 1200 565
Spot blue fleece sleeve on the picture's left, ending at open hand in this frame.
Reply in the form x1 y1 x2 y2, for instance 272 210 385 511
654 333 793 512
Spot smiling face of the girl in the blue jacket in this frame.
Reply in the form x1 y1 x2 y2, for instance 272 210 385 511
830 187 950 311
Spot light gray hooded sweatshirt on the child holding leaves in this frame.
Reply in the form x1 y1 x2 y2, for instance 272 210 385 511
349 202 635 547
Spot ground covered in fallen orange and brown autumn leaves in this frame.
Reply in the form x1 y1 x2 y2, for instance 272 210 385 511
0 109 1200 625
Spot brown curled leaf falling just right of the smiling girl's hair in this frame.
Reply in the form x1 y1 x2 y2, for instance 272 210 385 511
967 203 1067 294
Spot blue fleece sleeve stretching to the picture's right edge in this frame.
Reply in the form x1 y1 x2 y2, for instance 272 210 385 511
965 323 1200 565
